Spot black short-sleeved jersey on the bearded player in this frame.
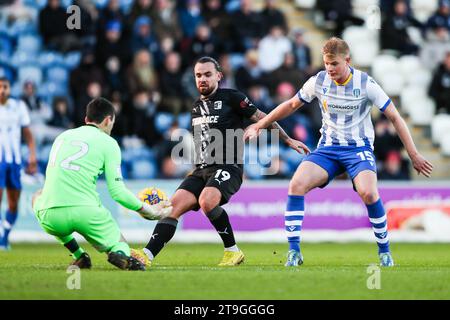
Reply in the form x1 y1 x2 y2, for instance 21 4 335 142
191 88 257 168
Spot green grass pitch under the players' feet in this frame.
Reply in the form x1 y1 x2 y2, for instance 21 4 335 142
0 243 450 300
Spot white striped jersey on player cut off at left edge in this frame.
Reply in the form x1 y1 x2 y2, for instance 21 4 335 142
0 98 30 164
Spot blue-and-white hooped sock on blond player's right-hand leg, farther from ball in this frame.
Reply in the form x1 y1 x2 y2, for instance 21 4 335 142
366 199 389 253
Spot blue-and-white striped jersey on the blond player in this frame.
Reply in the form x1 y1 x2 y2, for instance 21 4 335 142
297 68 391 149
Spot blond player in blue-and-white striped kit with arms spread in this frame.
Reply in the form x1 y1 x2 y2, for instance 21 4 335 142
245 37 433 266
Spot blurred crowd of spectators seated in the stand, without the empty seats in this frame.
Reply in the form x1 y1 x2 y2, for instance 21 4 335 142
0 0 450 179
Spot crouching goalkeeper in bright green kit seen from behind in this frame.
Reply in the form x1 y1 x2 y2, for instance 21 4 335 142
32 98 172 270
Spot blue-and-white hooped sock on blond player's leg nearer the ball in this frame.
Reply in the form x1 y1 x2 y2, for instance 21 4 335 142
284 195 305 252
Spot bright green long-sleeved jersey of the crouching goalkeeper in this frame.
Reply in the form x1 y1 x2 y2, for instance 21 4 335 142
35 125 142 211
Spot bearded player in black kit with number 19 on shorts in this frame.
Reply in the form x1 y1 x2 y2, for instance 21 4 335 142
134 57 309 266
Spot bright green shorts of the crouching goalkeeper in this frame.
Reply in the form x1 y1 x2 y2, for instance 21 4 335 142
36 206 130 256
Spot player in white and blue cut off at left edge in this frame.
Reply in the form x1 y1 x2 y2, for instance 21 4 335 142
0 77 37 250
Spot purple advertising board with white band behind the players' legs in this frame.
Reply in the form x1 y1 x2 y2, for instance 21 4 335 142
183 181 450 231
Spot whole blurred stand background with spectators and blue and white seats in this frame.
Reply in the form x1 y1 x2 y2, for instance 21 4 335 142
0 0 450 180
